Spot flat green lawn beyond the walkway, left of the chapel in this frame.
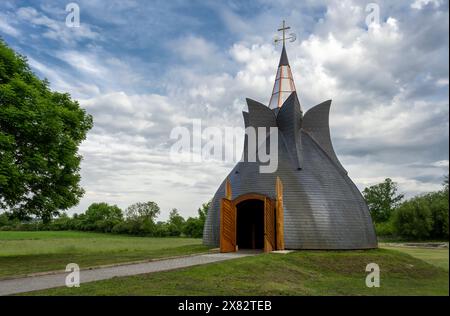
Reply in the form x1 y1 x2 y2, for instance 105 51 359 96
0 231 208 278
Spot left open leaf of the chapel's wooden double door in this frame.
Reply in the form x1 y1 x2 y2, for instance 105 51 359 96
220 199 236 252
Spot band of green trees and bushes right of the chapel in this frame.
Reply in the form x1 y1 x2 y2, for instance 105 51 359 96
363 175 449 240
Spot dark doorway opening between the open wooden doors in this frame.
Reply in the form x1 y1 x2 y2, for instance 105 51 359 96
236 200 264 249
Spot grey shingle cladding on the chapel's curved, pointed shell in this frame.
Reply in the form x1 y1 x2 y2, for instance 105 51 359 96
203 93 377 249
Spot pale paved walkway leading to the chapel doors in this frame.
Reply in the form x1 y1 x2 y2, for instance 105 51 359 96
0 251 259 295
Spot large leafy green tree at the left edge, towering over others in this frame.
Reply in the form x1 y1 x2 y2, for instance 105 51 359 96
0 39 92 222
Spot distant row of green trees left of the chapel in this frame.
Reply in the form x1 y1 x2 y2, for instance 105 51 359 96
0 201 211 238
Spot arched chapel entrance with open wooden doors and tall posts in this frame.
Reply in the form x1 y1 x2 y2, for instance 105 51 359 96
220 178 284 252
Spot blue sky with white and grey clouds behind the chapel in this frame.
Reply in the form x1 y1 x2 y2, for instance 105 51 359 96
0 0 449 219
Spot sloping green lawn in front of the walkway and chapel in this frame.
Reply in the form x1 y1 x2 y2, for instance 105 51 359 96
28 249 449 295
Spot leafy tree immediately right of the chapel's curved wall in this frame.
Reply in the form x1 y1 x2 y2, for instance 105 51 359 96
363 178 404 223
